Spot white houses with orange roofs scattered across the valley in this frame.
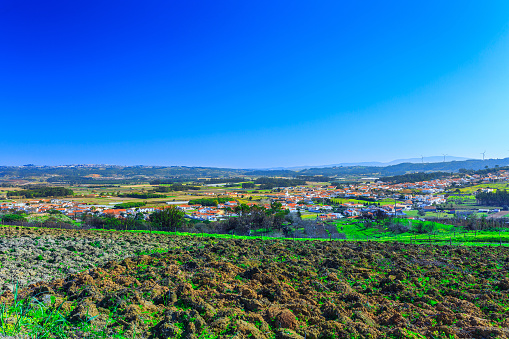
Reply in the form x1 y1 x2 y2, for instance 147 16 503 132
0 171 509 221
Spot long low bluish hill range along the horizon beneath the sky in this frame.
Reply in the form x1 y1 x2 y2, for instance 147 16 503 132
0 157 509 184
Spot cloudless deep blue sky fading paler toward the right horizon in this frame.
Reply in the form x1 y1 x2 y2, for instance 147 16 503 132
0 0 509 168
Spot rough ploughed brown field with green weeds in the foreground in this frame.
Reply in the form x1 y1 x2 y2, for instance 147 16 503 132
0 227 509 339
